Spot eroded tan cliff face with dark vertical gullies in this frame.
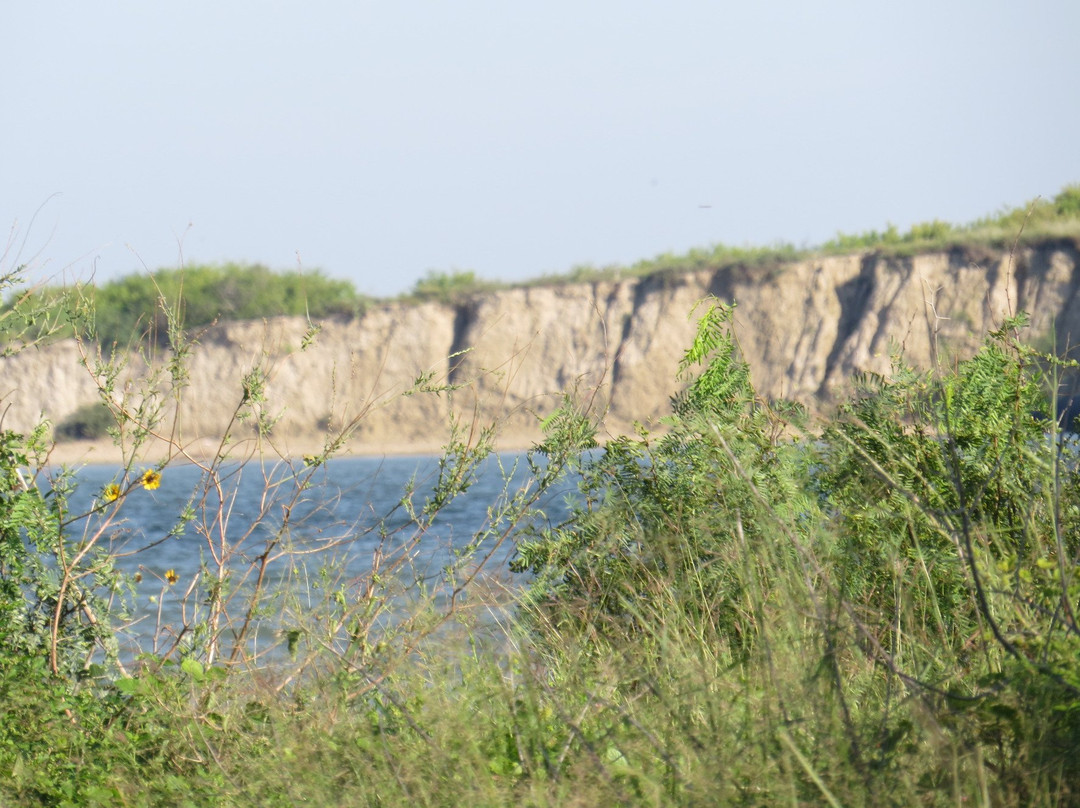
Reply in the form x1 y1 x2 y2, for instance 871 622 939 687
0 241 1080 450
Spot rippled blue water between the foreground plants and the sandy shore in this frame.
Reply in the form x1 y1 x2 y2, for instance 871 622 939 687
61 455 569 650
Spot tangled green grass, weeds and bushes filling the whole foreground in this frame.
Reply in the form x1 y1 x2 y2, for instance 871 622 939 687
0 250 1080 806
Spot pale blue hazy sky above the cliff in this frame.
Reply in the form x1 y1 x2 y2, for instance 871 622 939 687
0 0 1080 295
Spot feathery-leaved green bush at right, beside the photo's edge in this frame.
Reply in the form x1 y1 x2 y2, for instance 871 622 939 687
815 313 1076 646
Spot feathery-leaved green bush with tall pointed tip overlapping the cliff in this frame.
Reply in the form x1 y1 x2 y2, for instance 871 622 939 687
512 302 815 647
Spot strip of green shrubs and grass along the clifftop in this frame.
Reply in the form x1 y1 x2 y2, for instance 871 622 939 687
0 184 1080 348
